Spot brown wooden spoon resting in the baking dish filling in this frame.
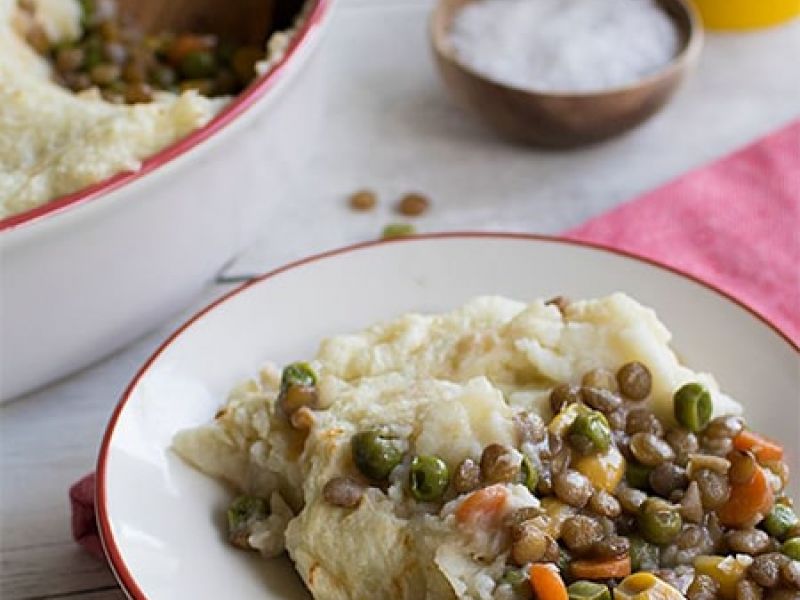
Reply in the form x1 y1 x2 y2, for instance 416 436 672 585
118 0 303 45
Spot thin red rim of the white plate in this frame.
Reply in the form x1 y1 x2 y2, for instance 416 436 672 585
95 232 800 600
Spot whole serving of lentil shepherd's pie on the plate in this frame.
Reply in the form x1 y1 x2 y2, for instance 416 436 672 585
174 293 800 600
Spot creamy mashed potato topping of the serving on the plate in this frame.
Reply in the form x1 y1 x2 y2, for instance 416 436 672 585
174 293 752 600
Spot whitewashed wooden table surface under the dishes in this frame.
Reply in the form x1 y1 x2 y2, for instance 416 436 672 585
0 0 800 600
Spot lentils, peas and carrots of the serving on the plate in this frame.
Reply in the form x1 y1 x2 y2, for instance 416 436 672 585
229 362 800 600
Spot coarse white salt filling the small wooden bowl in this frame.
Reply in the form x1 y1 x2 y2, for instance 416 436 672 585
450 0 680 92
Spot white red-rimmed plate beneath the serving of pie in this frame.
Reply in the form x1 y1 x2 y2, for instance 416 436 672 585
97 233 800 600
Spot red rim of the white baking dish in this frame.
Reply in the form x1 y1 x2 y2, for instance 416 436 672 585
0 0 332 233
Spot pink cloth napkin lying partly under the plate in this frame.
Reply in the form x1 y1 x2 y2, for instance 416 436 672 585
69 121 800 558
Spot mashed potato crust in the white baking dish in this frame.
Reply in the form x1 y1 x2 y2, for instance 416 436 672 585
0 0 311 219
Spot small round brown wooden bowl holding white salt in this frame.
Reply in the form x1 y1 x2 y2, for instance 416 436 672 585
431 0 703 148
